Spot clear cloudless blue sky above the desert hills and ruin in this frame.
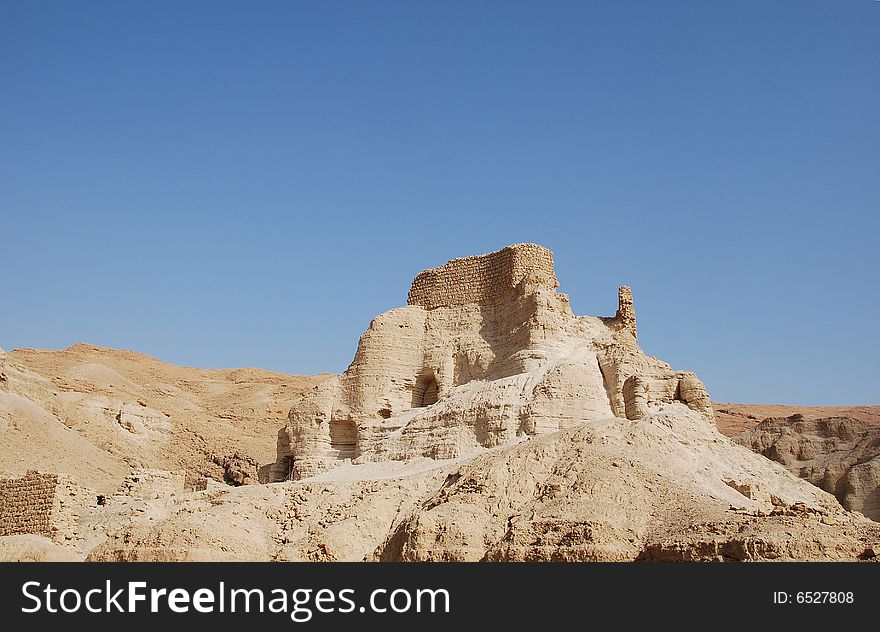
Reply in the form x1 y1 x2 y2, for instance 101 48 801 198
0 0 880 404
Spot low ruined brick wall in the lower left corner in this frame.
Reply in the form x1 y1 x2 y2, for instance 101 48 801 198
0 470 95 542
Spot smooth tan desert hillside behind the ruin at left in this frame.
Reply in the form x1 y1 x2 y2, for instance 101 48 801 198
0 344 326 493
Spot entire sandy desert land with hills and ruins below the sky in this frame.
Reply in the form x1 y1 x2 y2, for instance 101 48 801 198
0 244 880 561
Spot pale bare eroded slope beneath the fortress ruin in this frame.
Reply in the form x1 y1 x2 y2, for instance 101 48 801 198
81 404 880 561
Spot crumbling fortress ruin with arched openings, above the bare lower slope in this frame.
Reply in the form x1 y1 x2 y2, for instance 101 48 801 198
272 244 714 481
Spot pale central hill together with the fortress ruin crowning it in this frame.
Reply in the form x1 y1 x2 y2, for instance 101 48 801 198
22 244 880 561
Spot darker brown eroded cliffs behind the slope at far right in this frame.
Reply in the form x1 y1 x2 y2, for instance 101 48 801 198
734 415 880 521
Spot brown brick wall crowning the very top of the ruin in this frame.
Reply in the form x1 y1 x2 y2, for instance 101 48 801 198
407 244 558 309
